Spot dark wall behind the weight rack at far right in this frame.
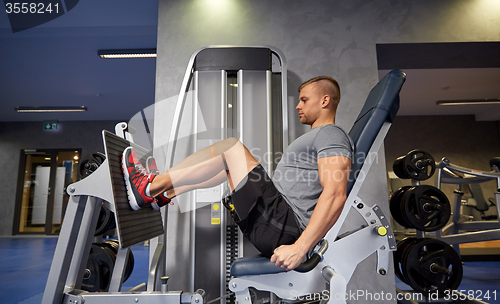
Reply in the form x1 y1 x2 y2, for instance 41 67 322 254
385 116 500 218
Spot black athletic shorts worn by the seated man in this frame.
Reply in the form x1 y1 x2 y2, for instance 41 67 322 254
231 165 302 257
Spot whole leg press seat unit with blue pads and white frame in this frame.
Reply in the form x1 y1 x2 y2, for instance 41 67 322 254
229 70 405 304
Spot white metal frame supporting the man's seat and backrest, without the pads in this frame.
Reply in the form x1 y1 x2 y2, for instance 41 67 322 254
229 122 396 304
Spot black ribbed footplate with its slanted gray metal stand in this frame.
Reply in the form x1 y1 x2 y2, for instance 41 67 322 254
42 123 204 304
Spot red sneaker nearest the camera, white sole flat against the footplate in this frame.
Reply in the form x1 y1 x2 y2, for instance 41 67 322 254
121 147 155 210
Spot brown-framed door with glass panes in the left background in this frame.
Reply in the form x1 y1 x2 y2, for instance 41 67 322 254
13 149 81 235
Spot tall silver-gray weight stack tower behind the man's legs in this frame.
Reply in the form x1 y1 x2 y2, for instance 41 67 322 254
155 46 288 304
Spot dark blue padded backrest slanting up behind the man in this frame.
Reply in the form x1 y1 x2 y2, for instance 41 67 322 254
347 70 406 195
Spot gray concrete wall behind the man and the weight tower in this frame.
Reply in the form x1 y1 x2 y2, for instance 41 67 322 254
155 0 500 302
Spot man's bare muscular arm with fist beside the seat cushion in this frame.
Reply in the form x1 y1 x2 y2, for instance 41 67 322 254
271 156 351 270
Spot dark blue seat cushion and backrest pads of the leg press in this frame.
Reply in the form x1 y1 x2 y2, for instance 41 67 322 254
230 70 406 277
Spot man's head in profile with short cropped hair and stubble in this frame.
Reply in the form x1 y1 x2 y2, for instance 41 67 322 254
296 76 340 127
